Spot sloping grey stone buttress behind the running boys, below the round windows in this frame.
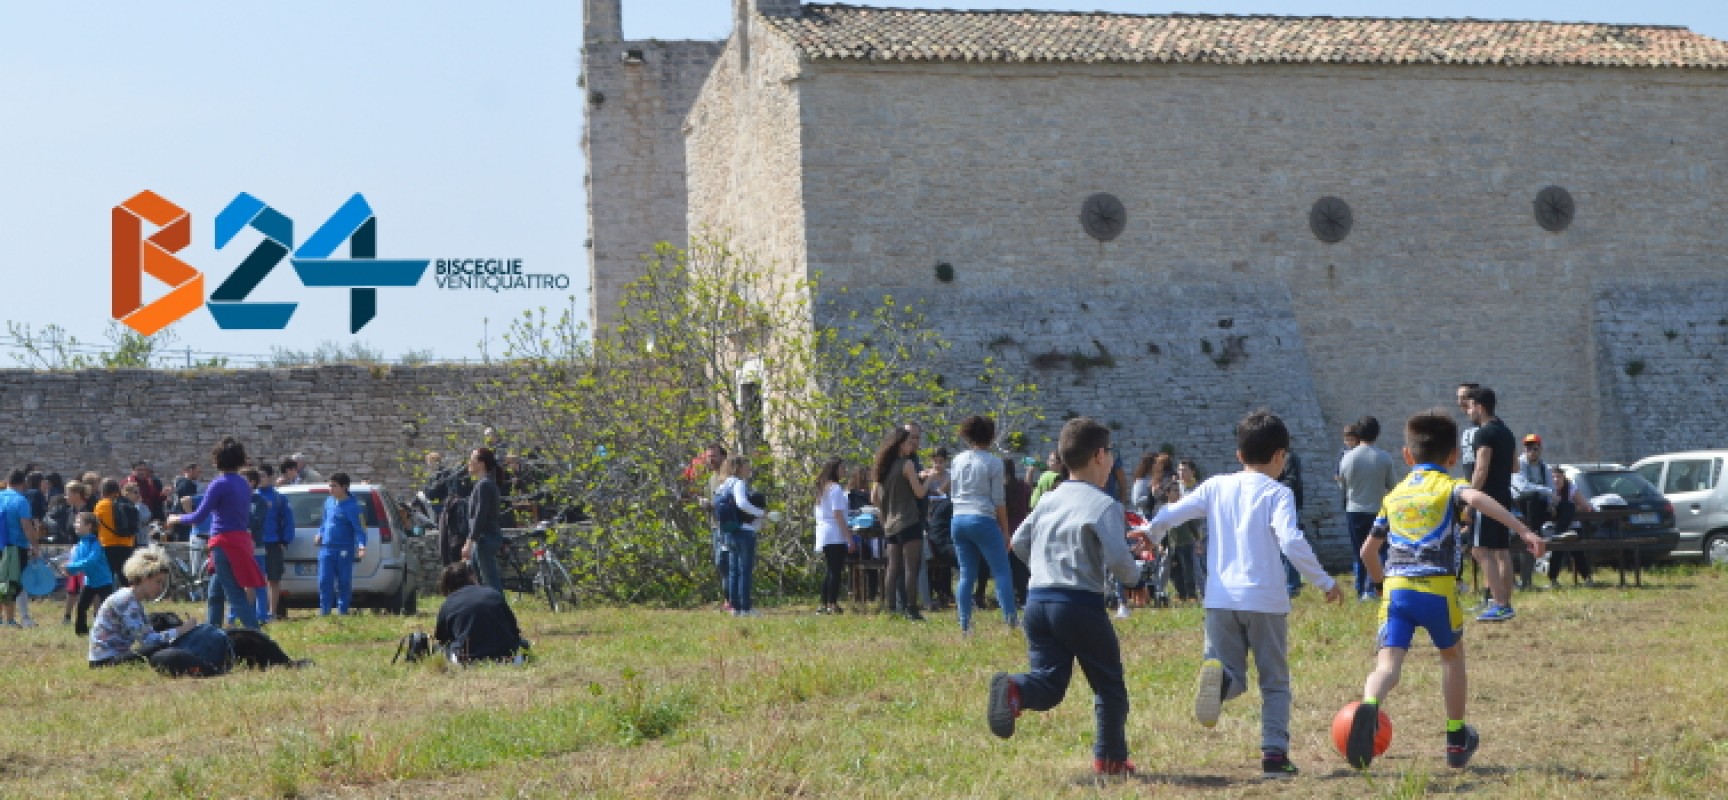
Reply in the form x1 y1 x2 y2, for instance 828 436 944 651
817 283 1350 568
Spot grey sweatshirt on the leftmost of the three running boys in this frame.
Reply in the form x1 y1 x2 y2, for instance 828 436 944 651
1013 480 1140 594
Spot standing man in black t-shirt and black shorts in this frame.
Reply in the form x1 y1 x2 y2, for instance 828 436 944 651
1469 385 1517 622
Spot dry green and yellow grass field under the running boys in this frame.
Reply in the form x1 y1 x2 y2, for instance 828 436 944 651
0 567 1728 798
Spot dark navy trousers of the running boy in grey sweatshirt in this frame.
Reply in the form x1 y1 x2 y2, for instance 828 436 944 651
1016 597 1128 760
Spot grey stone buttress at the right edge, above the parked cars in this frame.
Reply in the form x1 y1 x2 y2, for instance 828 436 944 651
1595 280 1728 463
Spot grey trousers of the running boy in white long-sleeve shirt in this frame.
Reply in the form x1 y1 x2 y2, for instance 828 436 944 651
1206 608 1291 753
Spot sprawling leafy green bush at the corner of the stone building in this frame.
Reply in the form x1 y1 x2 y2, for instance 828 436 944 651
438 238 1037 605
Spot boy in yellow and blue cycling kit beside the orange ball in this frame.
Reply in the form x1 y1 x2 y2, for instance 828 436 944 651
1344 410 1543 769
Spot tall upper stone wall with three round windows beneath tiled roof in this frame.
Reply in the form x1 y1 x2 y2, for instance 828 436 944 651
791 62 1728 460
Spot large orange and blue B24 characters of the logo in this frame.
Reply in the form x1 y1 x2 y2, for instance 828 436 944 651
112 192 432 335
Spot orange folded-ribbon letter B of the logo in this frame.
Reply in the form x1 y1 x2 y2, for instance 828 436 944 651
112 190 204 335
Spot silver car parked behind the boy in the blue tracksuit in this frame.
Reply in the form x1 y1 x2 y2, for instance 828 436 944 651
280 484 420 613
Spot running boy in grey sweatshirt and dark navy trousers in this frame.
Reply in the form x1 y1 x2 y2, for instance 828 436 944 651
988 416 1140 776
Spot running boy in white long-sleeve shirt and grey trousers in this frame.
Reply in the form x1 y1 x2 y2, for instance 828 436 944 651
1151 411 1343 778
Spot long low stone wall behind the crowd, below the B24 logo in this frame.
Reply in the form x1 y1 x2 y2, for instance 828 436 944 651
0 366 517 489
